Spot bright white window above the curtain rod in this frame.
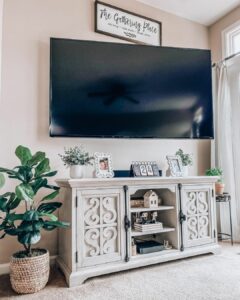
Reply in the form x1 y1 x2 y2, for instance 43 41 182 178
222 21 240 58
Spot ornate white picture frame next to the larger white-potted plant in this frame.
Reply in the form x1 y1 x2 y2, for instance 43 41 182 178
94 152 114 178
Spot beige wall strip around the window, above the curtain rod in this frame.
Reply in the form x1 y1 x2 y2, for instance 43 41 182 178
209 6 240 62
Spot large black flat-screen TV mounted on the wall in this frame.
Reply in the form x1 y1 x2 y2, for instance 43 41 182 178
50 38 213 139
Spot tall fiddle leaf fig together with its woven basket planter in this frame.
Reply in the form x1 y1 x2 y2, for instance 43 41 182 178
0 146 69 294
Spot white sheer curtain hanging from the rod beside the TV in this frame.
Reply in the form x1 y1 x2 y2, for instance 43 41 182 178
215 56 240 241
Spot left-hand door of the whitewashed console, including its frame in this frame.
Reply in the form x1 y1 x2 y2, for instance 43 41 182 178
77 189 124 267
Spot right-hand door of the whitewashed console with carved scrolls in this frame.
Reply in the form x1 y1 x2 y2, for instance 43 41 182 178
182 185 215 248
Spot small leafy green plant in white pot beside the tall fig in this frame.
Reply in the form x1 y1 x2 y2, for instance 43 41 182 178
59 145 94 178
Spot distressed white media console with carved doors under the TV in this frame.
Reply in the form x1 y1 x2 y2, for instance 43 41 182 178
57 177 220 287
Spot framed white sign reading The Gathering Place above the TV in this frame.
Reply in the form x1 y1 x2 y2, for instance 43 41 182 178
95 1 161 46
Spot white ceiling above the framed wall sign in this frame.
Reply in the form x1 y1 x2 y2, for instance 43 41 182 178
137 0 240 26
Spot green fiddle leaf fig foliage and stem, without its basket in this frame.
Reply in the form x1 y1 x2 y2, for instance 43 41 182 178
0 145 69 257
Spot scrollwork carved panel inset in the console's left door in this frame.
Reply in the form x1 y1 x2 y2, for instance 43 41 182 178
84 195 119 257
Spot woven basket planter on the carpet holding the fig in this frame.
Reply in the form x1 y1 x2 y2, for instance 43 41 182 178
10 249 49 294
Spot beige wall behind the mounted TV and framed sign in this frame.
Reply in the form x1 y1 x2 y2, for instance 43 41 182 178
0 0 210 263
